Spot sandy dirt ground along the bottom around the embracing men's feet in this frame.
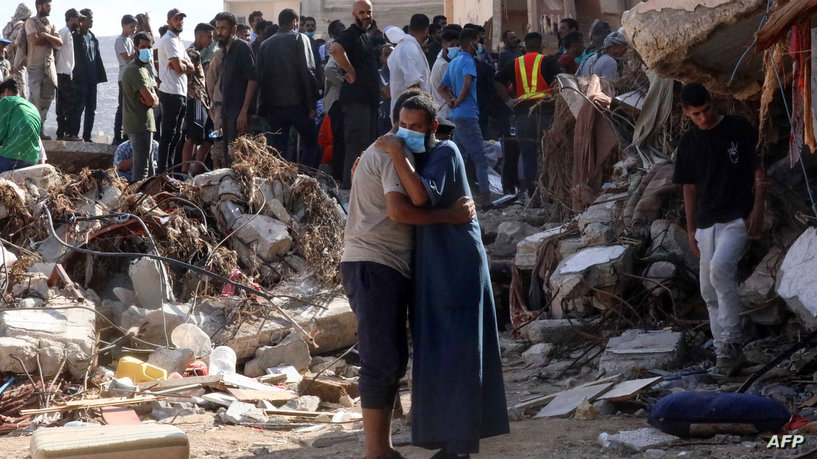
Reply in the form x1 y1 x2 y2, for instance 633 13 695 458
0 368 792 459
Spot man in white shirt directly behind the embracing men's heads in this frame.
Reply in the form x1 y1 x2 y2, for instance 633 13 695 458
388 14 431 121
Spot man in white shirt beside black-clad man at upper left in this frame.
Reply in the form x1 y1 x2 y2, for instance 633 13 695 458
56 8 85 140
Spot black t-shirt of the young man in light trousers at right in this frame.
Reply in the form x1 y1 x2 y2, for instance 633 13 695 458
672 116 758 229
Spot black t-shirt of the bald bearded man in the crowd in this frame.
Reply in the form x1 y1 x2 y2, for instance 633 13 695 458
336 24 380 105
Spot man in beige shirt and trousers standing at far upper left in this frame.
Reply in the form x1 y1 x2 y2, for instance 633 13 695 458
25 0 62 140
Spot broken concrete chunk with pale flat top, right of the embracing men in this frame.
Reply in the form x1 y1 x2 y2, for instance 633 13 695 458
550 245 632 319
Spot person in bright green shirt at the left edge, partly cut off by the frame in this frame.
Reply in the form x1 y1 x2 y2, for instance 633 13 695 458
0 79 42 172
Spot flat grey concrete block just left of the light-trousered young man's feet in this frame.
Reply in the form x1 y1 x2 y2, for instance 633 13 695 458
599 330 684 375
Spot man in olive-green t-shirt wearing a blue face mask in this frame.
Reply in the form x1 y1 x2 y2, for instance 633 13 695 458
122 32 159 182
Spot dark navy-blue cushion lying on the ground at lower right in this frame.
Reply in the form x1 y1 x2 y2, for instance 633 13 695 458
647 392 791 437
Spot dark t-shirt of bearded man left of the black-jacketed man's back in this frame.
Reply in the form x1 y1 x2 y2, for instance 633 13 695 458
221 38 258 118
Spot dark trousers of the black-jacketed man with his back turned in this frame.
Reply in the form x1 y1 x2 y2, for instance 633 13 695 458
264 106 321 169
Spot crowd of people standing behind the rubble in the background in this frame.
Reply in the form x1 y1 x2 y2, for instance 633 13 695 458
0 0 627 186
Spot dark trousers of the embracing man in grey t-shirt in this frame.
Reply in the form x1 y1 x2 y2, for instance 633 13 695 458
340 261 414 410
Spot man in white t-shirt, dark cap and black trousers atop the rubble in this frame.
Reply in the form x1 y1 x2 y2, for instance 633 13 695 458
156 8 195 174
